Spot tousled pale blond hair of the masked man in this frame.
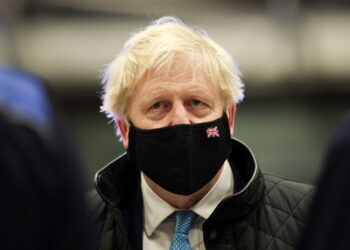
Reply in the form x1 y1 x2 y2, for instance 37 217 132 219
101 17 243 123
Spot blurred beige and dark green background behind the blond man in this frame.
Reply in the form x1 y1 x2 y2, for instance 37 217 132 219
0 0 350 187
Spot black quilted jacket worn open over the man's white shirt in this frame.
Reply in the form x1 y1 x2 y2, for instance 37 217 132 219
90 139 314 250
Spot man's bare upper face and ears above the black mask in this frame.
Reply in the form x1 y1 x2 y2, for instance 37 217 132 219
118 64 235 148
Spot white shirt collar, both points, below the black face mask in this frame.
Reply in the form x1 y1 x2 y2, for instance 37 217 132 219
141 161 233 237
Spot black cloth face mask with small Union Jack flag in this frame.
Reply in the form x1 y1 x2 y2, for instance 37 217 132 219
127 114 231 195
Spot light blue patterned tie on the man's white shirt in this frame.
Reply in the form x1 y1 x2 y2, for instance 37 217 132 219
170 210 197 250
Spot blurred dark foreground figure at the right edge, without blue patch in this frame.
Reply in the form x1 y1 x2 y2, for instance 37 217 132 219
299 112 350 250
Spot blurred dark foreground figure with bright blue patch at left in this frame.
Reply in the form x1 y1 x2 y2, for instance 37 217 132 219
0 66 96 250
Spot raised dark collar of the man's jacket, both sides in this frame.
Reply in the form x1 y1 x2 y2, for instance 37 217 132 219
95 138 264 223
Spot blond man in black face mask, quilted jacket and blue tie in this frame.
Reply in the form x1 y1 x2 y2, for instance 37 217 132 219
92 17 312 250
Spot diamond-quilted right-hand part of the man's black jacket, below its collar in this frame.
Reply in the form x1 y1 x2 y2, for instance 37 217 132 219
233 176 314 250
